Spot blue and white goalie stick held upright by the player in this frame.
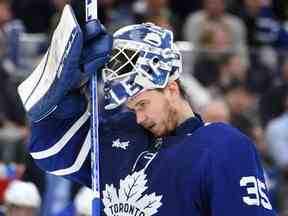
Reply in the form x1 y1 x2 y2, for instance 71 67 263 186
85 0 100 216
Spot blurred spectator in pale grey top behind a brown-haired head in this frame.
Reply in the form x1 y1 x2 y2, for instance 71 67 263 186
183 0 248 66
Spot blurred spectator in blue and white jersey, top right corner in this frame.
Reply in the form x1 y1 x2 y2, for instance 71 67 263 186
234 0 288 76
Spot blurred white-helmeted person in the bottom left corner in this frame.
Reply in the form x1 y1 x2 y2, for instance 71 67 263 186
4 180 41 216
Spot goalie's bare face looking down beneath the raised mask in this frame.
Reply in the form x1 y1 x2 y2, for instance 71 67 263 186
127 89 177 137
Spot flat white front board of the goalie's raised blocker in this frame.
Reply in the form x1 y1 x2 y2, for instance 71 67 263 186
18 5 77 111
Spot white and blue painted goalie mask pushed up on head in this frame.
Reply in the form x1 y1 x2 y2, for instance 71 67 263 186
102 23 182 110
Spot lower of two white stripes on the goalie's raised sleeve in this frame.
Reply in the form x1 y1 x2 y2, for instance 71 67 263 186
49 130 91 176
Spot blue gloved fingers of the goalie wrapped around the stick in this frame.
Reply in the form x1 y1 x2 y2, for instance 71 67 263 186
80 20 113 76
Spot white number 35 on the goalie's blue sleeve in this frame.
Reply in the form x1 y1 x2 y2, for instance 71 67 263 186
240 176 272 210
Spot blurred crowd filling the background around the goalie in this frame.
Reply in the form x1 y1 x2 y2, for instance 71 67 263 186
0 0 288 216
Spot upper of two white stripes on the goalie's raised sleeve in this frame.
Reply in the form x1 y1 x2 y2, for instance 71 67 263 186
30 109 90 159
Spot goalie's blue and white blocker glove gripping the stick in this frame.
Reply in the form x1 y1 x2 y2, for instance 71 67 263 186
18 5 112 122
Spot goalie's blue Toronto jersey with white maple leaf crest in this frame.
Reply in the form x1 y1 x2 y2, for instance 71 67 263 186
30 112 276 216
